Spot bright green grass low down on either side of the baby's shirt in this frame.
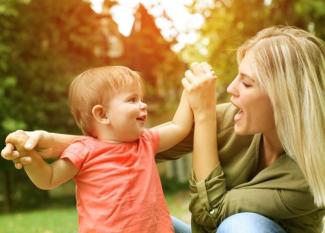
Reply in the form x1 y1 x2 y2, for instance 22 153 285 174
0 191 189 233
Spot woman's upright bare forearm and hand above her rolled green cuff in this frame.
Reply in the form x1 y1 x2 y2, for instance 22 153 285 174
183 63 220 181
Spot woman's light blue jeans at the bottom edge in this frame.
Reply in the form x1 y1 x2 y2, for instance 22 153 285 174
172 212 286 233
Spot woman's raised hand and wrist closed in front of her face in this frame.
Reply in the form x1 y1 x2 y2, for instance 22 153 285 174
182 62 216 118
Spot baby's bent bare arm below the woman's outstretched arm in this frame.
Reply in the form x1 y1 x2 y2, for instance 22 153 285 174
24 150 78 190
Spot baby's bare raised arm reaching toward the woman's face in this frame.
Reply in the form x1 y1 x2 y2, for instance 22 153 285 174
155 91 193 152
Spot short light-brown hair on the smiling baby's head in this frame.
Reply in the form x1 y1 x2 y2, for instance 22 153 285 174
69 66 142 136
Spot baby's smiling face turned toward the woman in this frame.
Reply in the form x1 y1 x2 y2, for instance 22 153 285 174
107 87 147 141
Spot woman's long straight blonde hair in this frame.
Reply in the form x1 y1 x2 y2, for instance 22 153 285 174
237 26 325 207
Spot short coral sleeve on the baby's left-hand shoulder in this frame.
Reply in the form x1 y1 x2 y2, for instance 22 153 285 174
60 140 89 170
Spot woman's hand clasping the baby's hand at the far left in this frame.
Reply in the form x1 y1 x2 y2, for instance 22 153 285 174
1 130 49 169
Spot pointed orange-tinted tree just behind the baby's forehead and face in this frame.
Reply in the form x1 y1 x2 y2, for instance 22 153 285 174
123 4 185 120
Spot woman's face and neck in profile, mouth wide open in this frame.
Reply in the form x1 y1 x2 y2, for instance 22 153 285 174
227 52 275 135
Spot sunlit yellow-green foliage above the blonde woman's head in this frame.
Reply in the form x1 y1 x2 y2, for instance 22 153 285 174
182 0 325 100
